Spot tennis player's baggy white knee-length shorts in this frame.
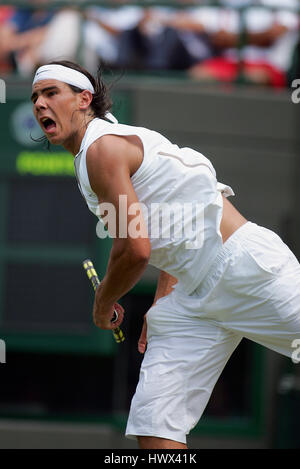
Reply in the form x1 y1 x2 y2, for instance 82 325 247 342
126 222 300 443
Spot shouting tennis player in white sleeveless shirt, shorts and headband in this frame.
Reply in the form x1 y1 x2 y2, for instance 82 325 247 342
31 62 300 449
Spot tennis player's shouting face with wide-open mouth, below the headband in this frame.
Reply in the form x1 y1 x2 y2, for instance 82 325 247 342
31 80 80 145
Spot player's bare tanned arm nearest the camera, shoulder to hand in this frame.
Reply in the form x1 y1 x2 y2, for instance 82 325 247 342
87 135 151 329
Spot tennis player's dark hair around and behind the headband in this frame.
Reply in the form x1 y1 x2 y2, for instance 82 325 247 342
48 60 112 119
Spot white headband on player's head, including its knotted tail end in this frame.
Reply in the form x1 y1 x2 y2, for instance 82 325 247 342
32 64 118 123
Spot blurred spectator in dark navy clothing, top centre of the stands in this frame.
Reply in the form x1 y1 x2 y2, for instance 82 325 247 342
114 2 212 70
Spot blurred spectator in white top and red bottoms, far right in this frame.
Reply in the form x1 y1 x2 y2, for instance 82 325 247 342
189 0 299 87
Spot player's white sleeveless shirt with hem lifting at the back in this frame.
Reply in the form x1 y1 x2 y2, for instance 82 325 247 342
74 118 234 294
